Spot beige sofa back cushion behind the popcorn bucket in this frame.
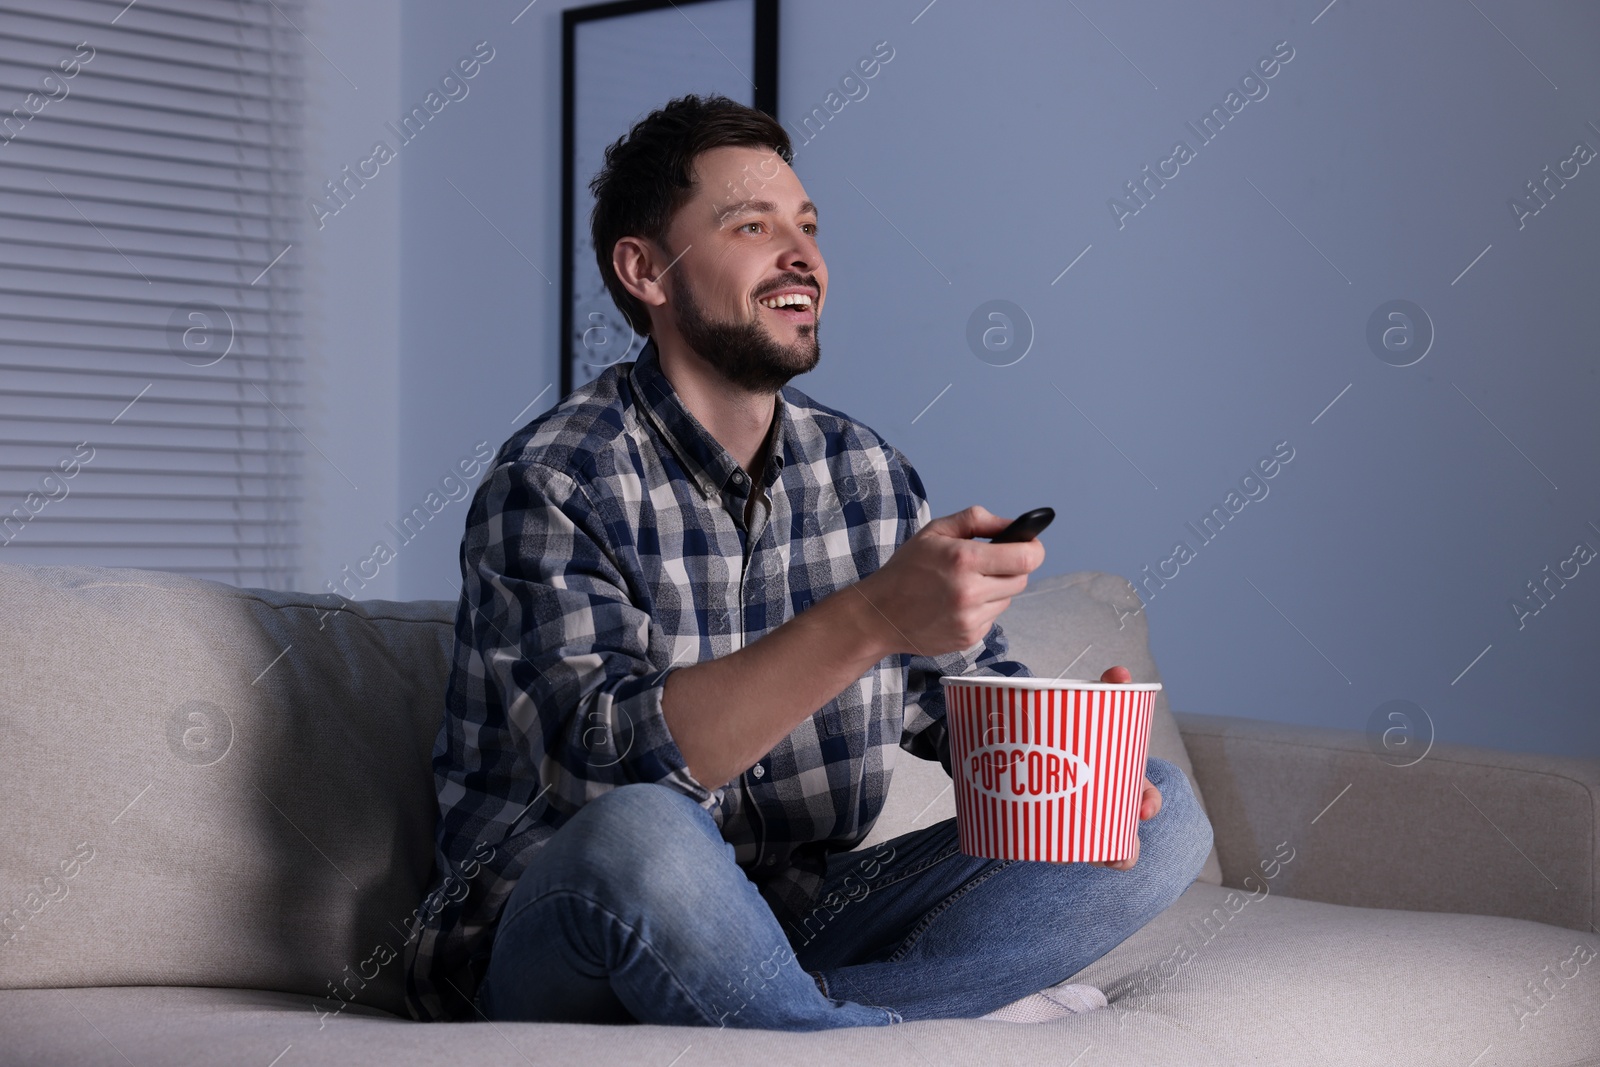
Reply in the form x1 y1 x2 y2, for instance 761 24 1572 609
858 571 1222 885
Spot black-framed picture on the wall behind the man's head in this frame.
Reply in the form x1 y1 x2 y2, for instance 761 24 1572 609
562 0 778 397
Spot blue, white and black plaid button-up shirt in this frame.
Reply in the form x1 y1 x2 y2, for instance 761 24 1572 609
405 341 1030 1019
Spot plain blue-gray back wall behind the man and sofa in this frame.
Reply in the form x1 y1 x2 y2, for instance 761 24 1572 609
387 0 1600 755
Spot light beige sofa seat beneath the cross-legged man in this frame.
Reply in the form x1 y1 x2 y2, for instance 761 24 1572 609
0 889 1600 1067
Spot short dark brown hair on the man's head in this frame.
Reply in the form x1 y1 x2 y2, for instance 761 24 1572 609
589 93 794 334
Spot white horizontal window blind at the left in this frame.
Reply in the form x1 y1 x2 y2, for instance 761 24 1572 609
0 0 306 589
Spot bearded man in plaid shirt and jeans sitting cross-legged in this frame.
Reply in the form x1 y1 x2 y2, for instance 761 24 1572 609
408 96 1211 1030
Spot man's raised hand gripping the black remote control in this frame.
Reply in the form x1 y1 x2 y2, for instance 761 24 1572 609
854 504 1045 656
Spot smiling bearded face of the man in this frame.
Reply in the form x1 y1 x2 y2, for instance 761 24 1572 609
651 147 827 392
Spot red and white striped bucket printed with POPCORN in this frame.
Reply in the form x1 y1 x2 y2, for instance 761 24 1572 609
939 675 1162 864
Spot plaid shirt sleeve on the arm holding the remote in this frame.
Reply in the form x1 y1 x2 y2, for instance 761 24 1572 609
462 461 723 825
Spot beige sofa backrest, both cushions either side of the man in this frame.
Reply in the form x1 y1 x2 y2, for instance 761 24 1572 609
0 565 1221 1014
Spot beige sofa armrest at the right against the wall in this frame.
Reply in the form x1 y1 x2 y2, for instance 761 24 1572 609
1174 712 1600 929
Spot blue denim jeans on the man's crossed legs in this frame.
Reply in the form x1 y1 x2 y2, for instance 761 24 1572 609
475 758 1211 1030
